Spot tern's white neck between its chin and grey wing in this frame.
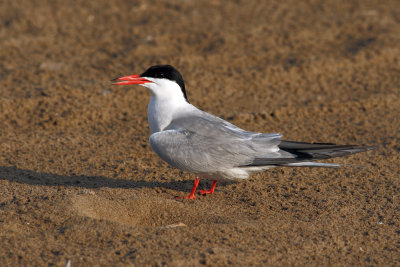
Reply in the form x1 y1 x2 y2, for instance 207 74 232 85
147 94 193 134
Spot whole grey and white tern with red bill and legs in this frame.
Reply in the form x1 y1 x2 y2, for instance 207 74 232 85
112 65 375 199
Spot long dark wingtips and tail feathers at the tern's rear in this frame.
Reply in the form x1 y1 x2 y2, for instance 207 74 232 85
242 141 376 167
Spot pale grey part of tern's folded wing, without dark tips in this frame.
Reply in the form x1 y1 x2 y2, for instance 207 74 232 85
150 115 284 173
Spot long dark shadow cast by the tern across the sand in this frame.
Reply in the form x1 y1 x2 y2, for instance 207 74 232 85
0 166 206 192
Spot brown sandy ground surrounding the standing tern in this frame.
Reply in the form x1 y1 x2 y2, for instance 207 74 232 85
0 0 400 267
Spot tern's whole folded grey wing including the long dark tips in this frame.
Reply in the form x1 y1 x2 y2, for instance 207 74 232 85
150 113 374 173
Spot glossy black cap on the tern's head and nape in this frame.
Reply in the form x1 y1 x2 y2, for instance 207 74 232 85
140 65 189 102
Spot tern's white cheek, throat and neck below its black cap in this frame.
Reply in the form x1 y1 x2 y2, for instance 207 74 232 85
144 77 193 134
